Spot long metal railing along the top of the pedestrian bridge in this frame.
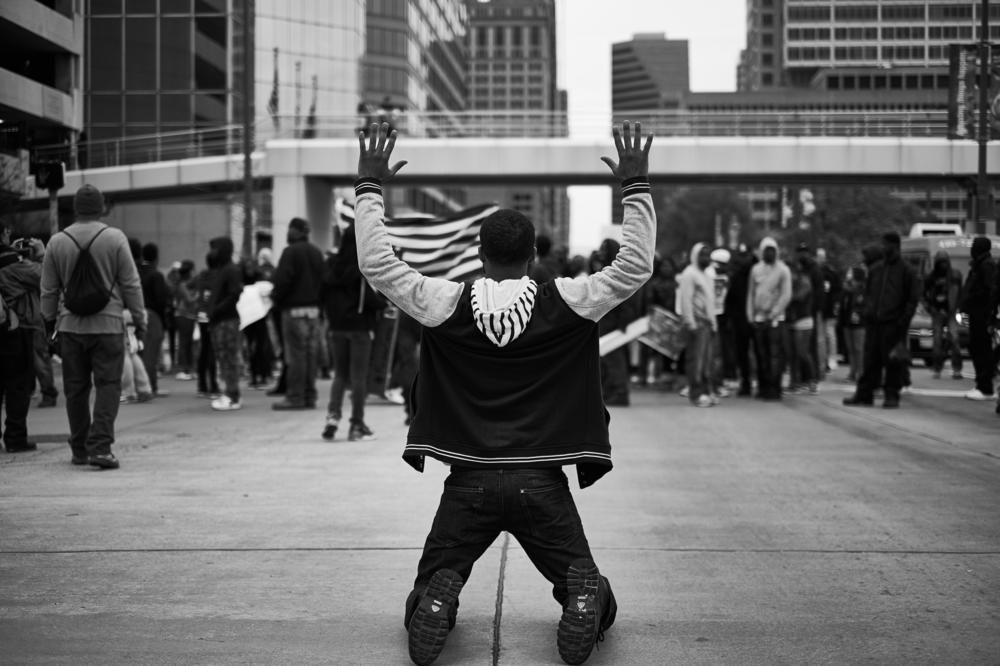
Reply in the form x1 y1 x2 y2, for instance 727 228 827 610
32 110 947 169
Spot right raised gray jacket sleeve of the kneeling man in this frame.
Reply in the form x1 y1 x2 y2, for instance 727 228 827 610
555 178 656 321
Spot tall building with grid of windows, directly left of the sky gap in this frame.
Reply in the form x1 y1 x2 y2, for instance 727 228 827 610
466 0 569 246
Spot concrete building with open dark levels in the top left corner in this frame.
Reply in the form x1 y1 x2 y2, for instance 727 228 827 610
0 0 83 165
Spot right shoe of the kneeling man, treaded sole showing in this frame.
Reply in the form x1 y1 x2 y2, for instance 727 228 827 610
556 558 617 664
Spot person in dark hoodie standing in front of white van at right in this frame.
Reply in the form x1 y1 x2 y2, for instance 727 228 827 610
923 250 962 379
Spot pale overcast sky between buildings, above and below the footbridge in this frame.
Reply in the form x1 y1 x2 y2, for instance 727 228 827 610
556 0 746 254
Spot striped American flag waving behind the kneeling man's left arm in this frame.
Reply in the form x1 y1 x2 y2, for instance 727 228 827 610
337 199 500 282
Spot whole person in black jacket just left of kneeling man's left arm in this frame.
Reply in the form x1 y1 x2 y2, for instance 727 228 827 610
322 227 385 442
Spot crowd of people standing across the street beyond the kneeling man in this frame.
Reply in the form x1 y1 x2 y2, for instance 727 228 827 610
0 180 1000 465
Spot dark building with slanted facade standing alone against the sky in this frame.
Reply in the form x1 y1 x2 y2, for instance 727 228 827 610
611 32 690 113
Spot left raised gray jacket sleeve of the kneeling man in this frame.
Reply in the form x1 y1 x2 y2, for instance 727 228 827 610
354 178 465 327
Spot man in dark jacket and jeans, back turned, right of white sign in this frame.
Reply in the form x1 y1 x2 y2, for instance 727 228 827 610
271 217 323 410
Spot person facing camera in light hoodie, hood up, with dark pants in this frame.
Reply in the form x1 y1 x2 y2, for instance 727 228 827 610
747 236 792 400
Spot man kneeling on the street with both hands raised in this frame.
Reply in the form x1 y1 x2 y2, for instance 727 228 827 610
355 122 656 664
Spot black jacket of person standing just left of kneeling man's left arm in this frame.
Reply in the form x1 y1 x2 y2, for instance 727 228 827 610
322 227 385 331
